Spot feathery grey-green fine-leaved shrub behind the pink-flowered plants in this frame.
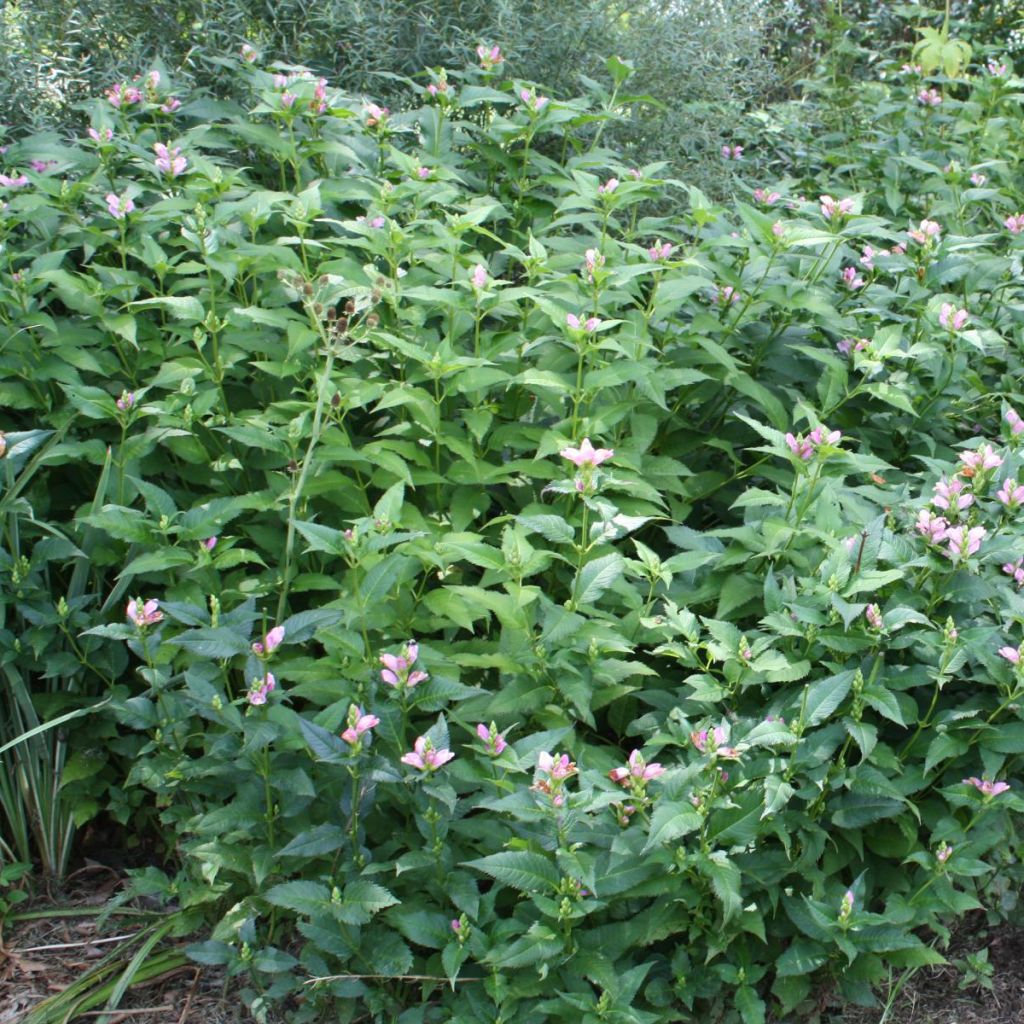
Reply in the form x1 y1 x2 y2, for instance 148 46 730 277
0 0 773 191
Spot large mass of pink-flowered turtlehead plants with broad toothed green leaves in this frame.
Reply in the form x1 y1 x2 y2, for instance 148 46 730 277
6 39 1024 1024
